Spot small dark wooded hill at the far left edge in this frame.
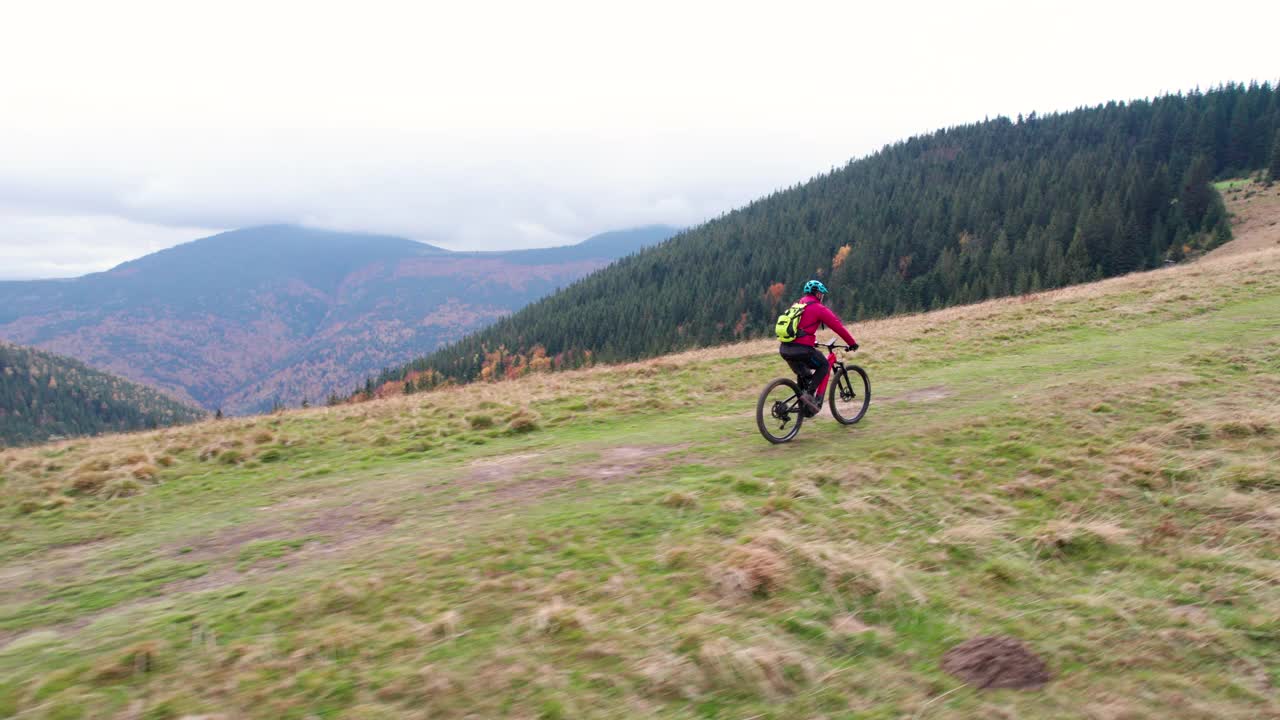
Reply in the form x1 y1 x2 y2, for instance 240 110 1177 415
0 342 205 446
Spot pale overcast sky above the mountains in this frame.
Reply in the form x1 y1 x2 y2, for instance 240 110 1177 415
0 0 1280 278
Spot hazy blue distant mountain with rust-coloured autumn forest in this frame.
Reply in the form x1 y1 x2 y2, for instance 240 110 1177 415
0 225 676 413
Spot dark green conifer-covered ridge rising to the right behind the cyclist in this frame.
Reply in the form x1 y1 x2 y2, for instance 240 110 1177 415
368 83 1280 395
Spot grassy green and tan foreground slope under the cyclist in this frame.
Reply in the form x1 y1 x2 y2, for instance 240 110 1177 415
0 242 1280 719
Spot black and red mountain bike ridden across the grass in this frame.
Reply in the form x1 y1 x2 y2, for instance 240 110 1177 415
755 340 872 443
